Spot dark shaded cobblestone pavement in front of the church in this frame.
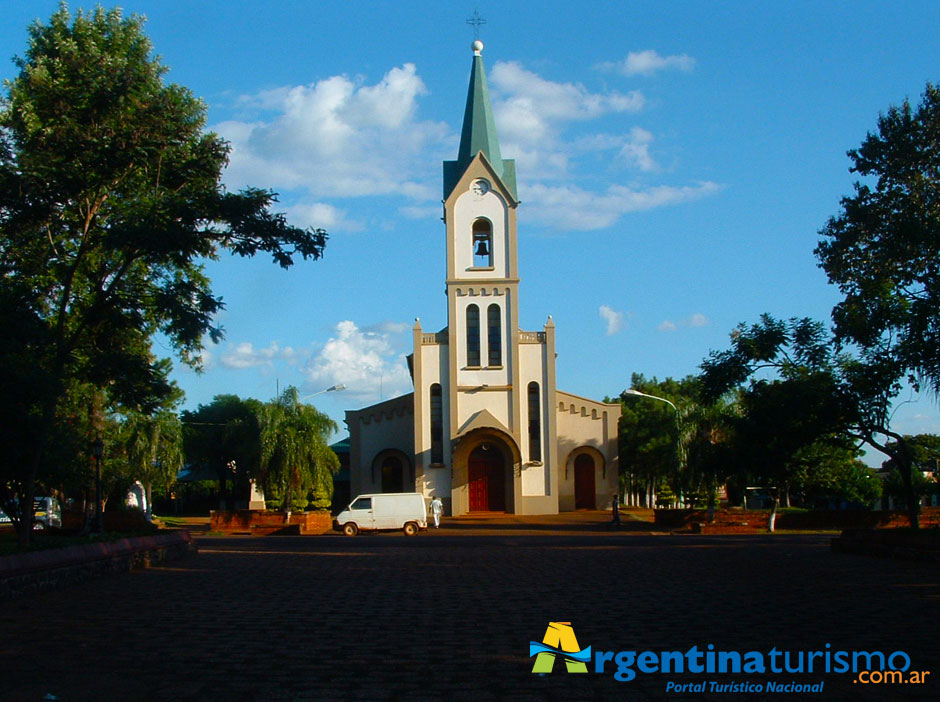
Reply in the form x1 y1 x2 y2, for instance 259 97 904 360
0 513 940 702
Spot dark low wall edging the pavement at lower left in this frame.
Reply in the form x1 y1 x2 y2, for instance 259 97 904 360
0 531 197 600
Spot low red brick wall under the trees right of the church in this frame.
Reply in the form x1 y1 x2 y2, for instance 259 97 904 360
655 507 940 533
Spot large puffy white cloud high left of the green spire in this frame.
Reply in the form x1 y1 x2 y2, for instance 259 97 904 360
213 63 449 201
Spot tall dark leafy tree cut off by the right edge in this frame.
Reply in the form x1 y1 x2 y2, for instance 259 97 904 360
816 83 940 528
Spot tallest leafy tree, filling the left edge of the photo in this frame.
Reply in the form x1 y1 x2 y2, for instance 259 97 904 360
0 5 327 542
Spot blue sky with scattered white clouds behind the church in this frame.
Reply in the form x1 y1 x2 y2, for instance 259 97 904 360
0 0 940 468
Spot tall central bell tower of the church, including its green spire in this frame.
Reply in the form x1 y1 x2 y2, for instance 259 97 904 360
444 40 521 440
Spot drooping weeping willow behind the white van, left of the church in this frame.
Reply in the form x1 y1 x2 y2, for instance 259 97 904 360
259 387 339 521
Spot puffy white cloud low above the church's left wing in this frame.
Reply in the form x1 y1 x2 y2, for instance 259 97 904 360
304 320 412 402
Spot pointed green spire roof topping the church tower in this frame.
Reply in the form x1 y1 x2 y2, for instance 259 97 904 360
444 40 516 199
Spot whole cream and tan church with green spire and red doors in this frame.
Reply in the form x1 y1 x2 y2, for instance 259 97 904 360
346 40 620 515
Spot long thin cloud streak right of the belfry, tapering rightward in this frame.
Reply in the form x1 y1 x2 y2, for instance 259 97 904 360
520 182 721 231
